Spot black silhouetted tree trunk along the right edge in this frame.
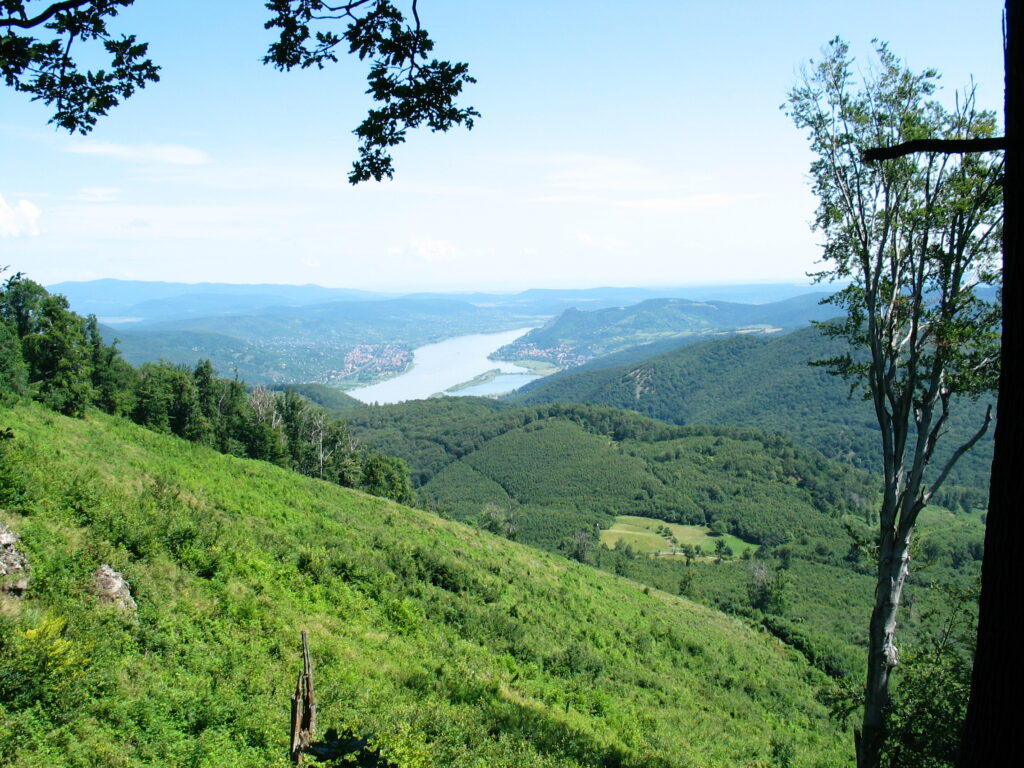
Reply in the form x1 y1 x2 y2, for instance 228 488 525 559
957 0 1024 768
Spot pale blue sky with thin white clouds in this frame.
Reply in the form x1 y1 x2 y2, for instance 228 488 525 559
0 0 1002 292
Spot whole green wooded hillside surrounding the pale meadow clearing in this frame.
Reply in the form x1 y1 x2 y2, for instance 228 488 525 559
349 398 984 685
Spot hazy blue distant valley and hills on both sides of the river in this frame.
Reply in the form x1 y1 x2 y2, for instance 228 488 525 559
51 280 827 389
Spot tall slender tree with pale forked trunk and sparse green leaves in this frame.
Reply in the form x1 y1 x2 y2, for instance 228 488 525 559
788 39 1001 768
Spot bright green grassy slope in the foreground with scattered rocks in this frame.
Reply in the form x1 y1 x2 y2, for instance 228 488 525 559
0 407 849 768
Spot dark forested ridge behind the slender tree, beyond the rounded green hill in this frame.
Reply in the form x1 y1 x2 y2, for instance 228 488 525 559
509 328 992 499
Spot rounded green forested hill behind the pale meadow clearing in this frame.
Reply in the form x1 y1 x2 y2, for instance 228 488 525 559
349 398 874 549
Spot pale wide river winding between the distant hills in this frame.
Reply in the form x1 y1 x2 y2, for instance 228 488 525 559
346 328 541 403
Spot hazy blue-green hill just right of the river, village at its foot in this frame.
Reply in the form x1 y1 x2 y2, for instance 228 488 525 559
495 293 830 368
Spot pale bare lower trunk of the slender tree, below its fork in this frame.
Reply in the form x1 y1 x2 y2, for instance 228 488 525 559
856 535 910 768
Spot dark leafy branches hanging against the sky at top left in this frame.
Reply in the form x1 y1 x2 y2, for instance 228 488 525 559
0 0 478 184
